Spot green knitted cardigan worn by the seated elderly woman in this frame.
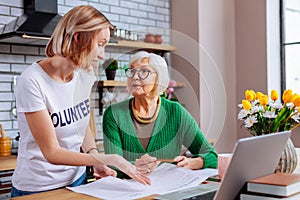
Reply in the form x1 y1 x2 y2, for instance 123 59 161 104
103 98 218 168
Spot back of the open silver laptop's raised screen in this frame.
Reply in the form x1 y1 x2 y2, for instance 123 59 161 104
215 131 291 200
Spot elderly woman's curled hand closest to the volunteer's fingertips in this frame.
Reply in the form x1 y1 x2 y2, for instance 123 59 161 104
135 154 160 176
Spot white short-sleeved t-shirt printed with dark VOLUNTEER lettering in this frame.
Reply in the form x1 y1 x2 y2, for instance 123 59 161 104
12 63 95 191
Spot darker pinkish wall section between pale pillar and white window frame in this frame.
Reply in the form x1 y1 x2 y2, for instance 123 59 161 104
235 0 268 141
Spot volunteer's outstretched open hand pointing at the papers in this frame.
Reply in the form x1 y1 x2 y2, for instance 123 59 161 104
91 154 151 185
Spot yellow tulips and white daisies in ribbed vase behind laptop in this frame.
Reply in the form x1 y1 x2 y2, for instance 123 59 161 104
238 90 300 173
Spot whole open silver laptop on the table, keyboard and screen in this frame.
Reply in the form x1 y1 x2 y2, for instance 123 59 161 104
155 131 291 200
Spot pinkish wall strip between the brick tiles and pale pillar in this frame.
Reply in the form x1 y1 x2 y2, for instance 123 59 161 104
170 0 200 123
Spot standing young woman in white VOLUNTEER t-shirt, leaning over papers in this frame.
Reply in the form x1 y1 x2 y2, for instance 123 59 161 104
12 6 150 197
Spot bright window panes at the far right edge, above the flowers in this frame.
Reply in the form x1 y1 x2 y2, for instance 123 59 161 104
281 0 300 94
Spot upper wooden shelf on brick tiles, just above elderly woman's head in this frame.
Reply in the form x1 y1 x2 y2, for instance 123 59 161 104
107 40 176 51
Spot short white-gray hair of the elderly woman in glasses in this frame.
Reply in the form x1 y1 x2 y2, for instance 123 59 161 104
129 51 170 95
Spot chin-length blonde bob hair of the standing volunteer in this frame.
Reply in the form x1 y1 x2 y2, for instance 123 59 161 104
46 5 113 65
